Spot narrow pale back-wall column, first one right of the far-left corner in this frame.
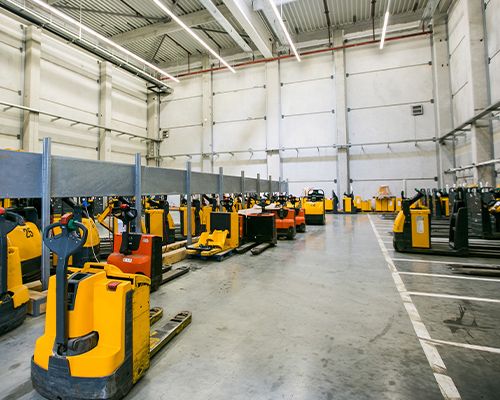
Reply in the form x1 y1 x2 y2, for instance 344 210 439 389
201 55 214 173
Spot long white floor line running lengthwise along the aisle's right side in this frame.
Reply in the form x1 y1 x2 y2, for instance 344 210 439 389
368 216 461 400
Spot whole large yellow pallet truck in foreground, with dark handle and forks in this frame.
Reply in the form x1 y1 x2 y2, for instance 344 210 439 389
31 214 191 400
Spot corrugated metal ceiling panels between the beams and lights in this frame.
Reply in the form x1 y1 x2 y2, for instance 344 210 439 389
46 0 446 63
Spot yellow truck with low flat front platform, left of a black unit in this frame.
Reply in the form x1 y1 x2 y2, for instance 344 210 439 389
187 212 240 257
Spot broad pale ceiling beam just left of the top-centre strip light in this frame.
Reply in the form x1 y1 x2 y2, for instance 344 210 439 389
223 0 273 57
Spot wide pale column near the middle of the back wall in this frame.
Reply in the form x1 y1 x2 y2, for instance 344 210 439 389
265 61 283 176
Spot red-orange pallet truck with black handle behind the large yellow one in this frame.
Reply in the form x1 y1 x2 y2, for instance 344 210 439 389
108 203 189 292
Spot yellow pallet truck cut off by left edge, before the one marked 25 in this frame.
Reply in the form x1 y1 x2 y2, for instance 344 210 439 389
0 208 29 335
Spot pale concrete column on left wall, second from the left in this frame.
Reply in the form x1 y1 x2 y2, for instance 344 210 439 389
98 61 113 161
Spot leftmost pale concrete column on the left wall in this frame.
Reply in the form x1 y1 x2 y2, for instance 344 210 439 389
21 25 42 152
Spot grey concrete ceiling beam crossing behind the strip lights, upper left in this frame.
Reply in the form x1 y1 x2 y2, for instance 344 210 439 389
111 6 230 45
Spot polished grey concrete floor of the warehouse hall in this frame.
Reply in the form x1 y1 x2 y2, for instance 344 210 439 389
0 215 500 400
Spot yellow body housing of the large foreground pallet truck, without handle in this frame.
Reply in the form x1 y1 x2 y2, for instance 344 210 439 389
33 263 150 388
